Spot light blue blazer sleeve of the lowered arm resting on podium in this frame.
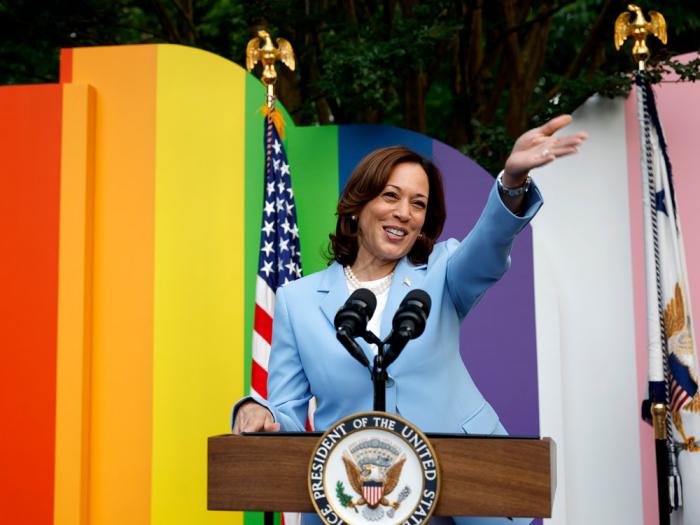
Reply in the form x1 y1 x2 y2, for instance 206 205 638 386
231 287 311 432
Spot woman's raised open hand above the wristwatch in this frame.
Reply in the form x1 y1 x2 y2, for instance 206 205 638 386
503 115 588 188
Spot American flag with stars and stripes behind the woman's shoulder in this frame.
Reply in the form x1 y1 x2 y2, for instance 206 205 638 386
251 118 301 399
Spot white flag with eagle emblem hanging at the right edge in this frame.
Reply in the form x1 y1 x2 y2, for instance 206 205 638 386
637 72 700 525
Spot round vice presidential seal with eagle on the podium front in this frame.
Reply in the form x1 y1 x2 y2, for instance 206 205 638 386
309 412 440 525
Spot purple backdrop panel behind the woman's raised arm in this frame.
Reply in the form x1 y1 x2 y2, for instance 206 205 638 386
433 141 539 436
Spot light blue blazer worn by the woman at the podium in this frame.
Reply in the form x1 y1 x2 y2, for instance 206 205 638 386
231 184 542 525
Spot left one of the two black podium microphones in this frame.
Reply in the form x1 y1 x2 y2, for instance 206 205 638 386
333 288 377 366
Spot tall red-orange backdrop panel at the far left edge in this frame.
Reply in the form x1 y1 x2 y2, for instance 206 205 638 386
0 85 62 525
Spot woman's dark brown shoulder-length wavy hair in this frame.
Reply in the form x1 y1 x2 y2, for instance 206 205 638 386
328 146 446 266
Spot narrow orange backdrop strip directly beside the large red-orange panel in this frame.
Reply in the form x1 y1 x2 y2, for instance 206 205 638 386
54 84 95 525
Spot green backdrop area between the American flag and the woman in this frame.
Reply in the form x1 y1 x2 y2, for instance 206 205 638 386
287 126 338 275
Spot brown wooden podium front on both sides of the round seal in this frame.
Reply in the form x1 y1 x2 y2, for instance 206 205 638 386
207 433 556 518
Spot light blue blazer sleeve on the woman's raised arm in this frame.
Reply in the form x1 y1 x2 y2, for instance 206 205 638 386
446 182 542 319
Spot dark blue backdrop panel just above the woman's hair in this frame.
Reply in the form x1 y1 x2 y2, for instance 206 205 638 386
338 124 433 195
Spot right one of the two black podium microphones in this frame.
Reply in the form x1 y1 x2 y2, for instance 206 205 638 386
384 290 431 368
